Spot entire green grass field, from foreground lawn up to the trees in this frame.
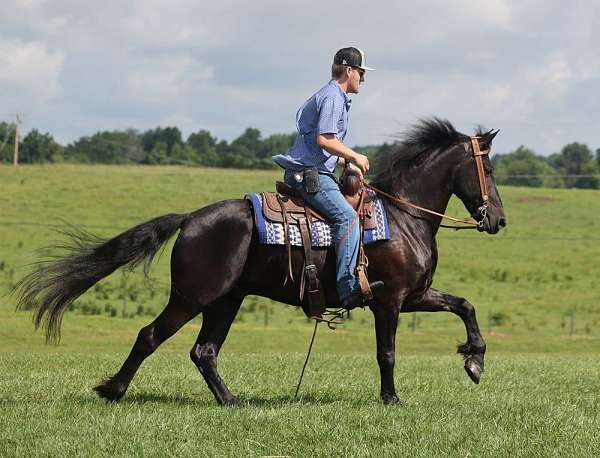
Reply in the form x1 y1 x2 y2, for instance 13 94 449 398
0 166 600 456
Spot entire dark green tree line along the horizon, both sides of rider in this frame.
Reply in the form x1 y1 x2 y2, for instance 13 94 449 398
0 122 600 189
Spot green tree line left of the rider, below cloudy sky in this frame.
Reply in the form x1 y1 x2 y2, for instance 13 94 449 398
0 123 296 169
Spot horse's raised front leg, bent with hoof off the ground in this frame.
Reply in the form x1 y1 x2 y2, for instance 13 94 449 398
402 288 485 383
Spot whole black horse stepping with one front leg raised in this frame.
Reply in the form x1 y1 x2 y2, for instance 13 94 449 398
18 118 505 405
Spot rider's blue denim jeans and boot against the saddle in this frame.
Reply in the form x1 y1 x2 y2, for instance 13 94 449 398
283 170 360 302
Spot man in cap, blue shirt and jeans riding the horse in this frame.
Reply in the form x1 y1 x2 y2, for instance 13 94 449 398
273 47 383 309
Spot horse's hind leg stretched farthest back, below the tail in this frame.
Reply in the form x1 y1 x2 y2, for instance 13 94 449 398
94 291 200 401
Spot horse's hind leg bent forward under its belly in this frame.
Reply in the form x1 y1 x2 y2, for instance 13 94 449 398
190 294 243 405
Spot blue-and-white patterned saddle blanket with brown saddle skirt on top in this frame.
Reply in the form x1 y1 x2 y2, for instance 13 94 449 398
244 191 390 248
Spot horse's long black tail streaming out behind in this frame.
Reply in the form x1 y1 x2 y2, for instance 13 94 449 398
13 214 188 342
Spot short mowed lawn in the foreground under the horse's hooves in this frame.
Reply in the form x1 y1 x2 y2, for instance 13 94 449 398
0 312 600 457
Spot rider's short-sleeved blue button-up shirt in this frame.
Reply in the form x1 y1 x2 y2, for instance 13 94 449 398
273 80 351 173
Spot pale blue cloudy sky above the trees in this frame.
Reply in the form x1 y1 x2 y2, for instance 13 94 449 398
0 0 600 155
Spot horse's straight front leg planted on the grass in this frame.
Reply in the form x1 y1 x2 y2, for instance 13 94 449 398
371 305 400 404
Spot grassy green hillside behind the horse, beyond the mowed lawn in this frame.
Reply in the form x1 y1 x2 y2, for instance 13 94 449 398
0 165 600 337
